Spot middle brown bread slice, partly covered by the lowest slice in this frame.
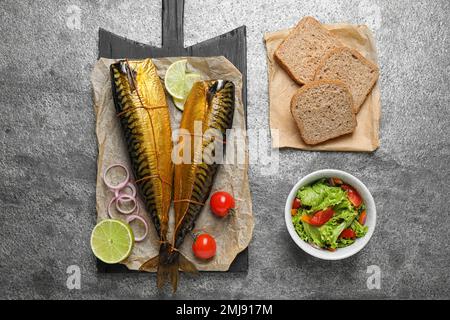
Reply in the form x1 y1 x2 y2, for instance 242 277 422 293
314 47 380 113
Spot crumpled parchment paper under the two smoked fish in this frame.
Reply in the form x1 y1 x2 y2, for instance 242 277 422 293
91 57 254 271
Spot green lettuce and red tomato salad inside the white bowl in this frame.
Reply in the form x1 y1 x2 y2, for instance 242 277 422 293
291 178 369 251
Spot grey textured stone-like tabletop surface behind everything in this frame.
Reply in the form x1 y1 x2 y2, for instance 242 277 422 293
0 0 450 299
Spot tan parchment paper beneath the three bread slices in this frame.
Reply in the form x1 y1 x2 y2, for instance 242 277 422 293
264 24 381 152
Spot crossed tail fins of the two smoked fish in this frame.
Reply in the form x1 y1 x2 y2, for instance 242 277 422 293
139 243 198 293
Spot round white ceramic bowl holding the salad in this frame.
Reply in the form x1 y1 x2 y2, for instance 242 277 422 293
285 169 377 260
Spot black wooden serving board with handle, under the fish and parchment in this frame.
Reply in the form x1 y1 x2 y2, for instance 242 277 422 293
97 0 248 273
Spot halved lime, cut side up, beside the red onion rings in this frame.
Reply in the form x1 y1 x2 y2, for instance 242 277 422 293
91 219 134 264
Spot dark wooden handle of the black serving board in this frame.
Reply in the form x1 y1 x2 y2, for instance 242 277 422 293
161 0 184 48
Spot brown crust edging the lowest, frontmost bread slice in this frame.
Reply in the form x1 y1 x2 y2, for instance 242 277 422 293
290 80 357 145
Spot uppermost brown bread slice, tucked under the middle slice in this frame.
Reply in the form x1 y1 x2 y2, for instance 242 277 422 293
275 17 342 84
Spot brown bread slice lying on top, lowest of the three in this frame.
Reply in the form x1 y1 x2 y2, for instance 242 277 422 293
291 80 356 145
